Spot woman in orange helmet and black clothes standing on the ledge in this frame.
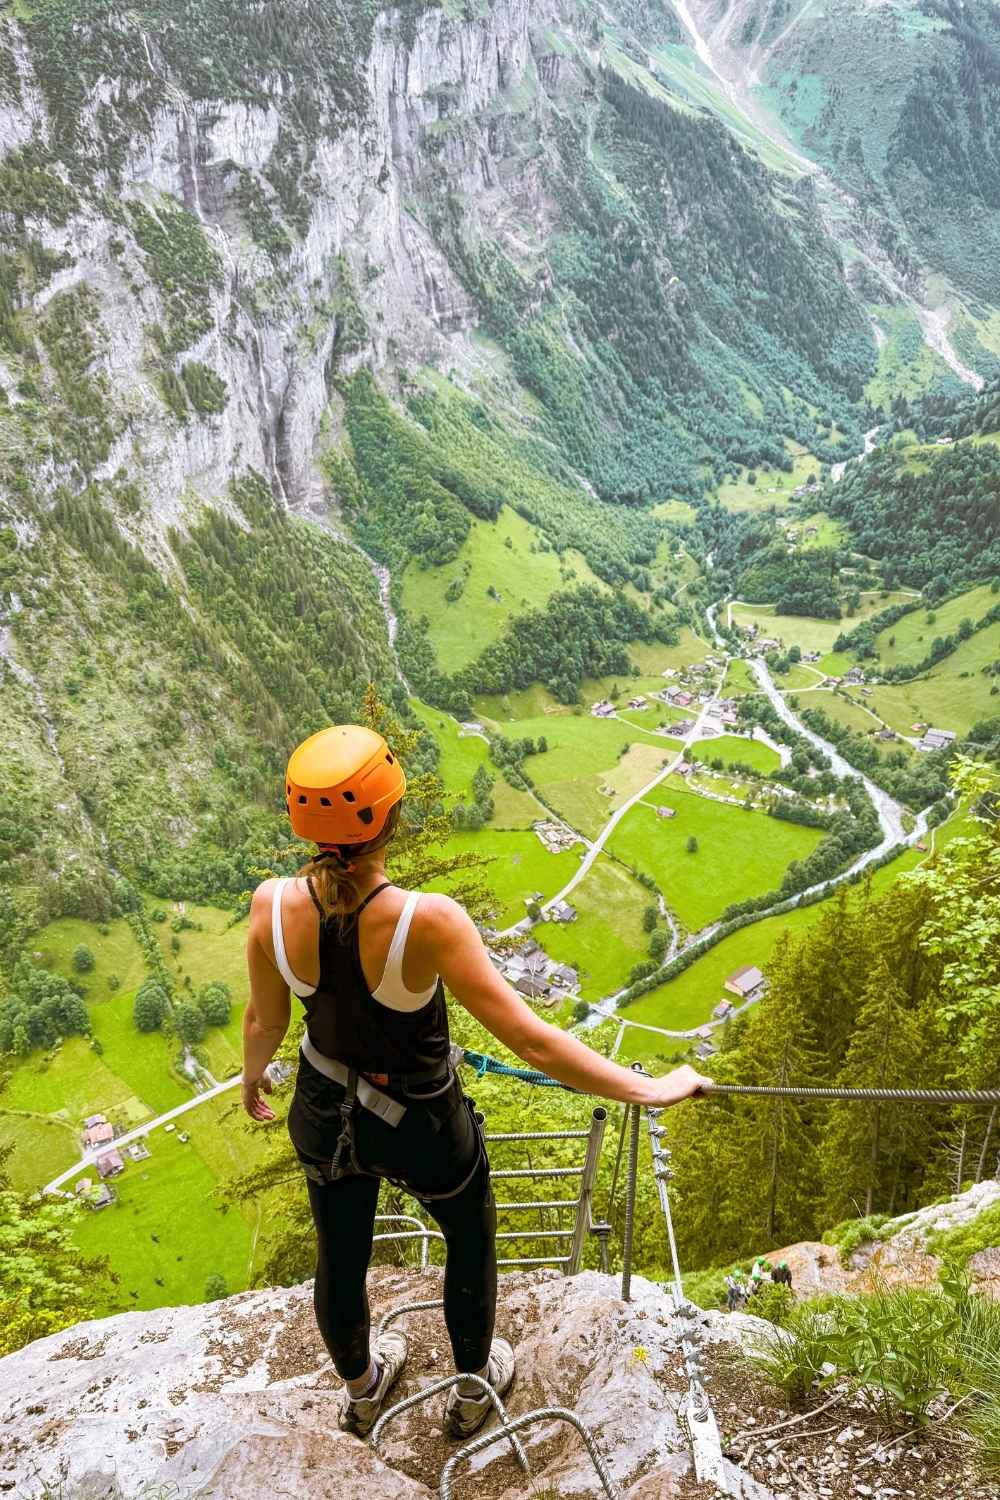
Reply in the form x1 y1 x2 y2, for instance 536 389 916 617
243 725 706 1437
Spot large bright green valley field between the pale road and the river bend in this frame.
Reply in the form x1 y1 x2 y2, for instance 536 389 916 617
609 779 823 932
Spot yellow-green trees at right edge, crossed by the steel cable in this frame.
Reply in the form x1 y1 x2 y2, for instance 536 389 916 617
669 771 1000 1265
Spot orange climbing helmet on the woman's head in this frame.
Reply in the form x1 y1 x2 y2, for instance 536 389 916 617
285 725 406 845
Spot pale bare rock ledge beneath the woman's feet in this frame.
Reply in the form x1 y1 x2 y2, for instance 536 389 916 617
0 1269 773 1500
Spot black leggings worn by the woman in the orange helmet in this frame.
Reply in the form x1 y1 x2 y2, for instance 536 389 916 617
288 1058 496 1380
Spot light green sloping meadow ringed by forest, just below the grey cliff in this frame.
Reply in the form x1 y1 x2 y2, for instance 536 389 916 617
402 506 604 672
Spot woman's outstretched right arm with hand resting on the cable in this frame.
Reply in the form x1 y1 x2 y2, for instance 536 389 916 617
414 896 709 1107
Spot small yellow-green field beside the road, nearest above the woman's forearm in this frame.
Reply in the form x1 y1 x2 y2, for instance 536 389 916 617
532 855 652 1001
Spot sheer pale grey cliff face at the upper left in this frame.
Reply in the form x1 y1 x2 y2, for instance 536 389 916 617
0 0 585 534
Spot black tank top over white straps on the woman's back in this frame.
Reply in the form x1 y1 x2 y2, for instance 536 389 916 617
300 881 451 1076
